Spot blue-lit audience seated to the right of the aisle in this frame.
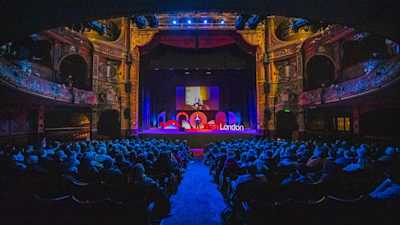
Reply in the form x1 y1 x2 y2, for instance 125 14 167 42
204 138 400 224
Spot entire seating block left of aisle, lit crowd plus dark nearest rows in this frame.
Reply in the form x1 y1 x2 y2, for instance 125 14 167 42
0 139 191 225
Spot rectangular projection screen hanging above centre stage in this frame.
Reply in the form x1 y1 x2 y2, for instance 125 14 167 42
176 86 219 111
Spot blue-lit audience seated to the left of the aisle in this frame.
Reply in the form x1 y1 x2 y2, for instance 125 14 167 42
0 139 191 223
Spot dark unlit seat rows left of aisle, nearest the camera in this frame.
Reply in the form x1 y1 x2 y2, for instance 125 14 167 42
0 177 159 225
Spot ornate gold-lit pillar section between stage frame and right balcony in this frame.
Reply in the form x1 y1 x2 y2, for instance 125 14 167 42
264 16 304 136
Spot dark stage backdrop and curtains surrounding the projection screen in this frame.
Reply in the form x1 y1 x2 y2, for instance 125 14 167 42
140 45 256 127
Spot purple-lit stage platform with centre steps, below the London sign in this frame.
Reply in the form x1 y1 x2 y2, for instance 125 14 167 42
139 129 263 148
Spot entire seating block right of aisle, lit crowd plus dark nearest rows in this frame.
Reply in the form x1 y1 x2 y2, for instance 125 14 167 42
205 139 400 225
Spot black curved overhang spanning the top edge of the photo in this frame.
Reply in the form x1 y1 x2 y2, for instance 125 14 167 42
0 0 400 43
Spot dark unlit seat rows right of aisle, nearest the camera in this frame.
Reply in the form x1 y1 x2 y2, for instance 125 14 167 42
225 183 400 225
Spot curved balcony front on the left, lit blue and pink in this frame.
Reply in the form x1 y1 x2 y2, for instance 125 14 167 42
0 59 97 105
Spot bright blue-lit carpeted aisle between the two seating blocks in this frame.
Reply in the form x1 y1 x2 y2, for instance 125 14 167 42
161 161 225 225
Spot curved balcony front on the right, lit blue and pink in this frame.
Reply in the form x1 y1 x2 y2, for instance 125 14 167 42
299 57 400 106
